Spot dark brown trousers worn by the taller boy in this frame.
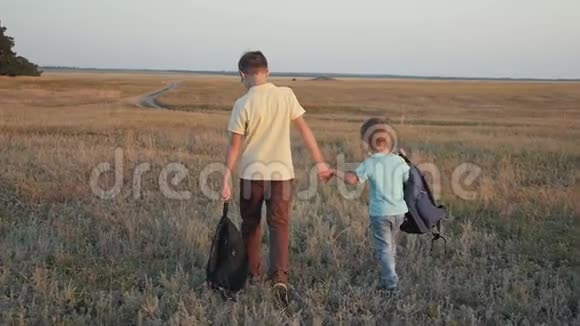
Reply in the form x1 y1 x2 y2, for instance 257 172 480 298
240 179 292 283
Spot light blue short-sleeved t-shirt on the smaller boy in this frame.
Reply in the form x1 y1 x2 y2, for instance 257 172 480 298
354 153 409 216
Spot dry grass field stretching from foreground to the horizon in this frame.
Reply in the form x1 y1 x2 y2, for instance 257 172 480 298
0 73 580 325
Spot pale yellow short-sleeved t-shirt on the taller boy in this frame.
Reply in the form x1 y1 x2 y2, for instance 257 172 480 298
228 83 304 180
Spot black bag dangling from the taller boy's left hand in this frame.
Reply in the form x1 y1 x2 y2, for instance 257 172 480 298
206 203 248 295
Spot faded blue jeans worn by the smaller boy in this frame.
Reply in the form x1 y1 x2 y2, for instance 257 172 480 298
371 215 405 289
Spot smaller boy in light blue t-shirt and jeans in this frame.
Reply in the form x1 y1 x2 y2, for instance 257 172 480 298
333 118 409 293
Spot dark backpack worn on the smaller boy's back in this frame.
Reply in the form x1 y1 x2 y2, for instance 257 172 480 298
399 154 448 249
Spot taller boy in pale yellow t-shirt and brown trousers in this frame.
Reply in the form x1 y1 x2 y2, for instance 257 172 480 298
222 51 331 302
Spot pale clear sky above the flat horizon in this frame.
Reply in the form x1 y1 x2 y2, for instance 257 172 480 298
0 0 580 78
